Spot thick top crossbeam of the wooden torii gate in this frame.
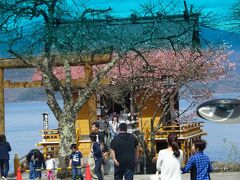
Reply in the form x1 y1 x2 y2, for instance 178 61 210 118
0 54 111 69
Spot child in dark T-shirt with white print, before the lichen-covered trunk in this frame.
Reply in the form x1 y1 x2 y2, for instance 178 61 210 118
69 144 83 180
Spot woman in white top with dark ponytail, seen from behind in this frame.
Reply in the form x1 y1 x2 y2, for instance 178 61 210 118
156 133 183 180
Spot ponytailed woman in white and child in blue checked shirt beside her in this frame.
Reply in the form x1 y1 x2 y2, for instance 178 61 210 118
156 133 212 180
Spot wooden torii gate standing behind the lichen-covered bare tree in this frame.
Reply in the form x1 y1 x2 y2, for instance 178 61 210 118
0 54 111 134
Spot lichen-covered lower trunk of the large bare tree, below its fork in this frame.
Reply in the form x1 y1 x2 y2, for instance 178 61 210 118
57 113 76 179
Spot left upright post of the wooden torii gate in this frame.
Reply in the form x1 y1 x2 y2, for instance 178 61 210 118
0 69 5 134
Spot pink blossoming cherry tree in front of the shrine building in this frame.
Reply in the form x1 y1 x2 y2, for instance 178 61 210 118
95 47 235 158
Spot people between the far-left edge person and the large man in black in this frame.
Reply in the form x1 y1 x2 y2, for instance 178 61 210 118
24 114 119 180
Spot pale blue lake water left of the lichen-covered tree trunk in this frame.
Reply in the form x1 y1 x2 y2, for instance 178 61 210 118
5 102 57 171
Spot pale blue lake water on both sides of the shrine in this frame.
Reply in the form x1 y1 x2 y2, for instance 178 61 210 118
5 99 240 171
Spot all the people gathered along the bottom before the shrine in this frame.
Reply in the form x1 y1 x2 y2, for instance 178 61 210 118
0 116 212 180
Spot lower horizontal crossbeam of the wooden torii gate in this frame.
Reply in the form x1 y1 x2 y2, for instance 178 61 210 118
3 78 111 88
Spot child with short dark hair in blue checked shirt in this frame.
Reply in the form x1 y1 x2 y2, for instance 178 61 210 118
182 139 213 180
